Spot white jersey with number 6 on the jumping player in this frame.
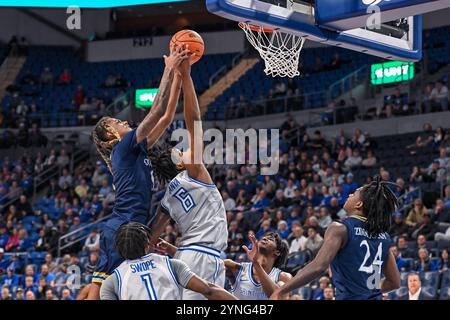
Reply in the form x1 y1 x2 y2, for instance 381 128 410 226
161 170 228 251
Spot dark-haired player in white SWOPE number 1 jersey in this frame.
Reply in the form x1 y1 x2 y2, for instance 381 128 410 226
100 222 236 300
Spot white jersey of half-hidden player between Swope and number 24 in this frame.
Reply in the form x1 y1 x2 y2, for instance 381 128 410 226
230 262 281 300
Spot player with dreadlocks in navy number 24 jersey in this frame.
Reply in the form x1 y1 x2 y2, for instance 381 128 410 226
271 176 400 300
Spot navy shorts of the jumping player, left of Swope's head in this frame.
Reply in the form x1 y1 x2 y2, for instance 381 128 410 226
92 227 124 284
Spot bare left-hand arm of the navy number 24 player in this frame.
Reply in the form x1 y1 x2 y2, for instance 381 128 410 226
270 222 347 300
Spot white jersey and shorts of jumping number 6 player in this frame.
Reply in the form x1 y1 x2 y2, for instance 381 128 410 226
161 171 228 300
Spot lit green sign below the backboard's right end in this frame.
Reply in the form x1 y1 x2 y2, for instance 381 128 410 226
370 61 414 85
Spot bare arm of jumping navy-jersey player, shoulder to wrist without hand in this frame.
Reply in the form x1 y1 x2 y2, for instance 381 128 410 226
136 68 175 139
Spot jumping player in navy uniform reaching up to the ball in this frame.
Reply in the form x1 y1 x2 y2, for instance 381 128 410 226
88 46 189 299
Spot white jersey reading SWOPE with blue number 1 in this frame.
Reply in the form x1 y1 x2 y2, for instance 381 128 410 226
114 253 182 300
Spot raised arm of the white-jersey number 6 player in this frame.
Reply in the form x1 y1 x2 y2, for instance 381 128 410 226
180 60 212 183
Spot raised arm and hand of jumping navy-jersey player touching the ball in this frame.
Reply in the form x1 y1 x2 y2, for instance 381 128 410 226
136 46 189 146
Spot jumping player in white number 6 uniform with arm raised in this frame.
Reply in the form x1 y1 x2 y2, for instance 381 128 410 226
152 57 228 300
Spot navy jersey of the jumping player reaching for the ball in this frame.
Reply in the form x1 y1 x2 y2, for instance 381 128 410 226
107 129 153 229
